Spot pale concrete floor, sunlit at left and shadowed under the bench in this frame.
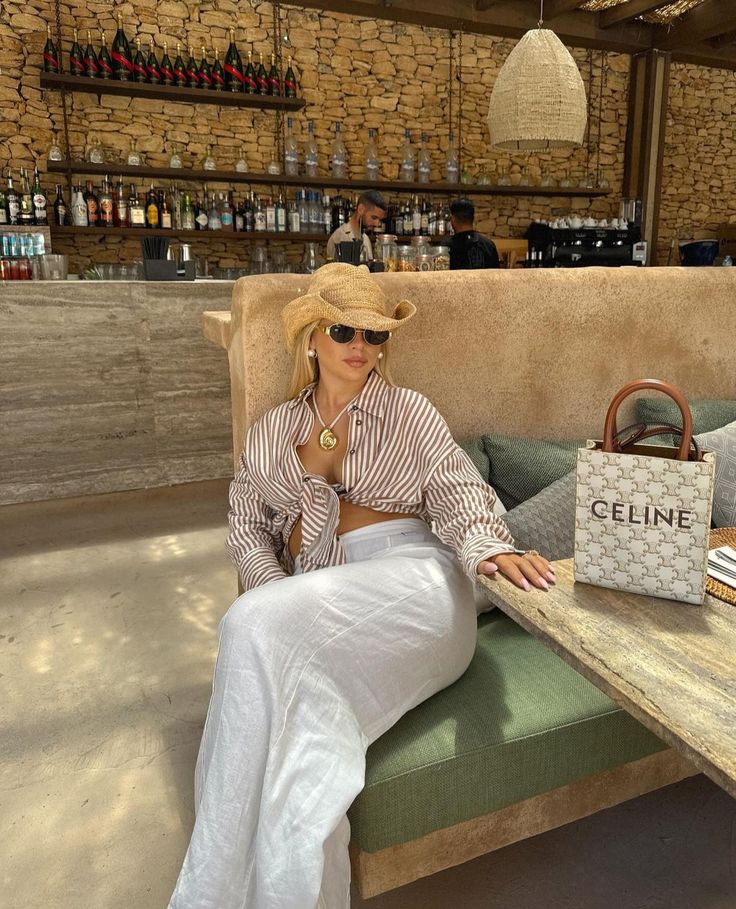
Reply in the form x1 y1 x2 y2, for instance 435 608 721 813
0 482 736 909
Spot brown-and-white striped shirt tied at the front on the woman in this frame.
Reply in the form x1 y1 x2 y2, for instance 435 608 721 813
227 372 514 590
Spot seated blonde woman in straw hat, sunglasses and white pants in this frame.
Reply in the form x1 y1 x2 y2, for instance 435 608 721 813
170 263 554 909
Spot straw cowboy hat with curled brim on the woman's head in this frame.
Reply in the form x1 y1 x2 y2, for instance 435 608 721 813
281 262 416 353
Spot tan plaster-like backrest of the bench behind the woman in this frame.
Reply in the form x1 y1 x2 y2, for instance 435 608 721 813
216 268 736 456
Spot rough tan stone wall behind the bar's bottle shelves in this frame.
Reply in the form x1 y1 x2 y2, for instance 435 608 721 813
0 0 736 266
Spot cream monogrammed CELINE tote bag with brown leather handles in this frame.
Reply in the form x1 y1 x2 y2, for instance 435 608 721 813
575 379 715 604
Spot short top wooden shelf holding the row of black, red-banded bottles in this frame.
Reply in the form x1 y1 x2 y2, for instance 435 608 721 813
41 73 306 111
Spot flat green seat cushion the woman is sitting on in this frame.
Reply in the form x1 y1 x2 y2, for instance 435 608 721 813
349 611 666 852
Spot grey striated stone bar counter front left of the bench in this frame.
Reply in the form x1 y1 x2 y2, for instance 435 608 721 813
0 281 232 504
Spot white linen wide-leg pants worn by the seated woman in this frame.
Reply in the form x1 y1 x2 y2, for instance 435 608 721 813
169 519 477 909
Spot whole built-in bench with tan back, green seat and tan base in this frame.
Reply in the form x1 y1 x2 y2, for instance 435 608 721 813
203 268 736 897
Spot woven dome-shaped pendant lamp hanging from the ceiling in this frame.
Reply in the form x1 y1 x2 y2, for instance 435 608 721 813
488 6 588 151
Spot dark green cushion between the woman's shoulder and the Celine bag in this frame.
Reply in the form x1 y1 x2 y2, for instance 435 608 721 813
483 435 586 509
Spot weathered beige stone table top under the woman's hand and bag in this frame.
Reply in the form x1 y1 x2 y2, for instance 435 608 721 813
481 559 736 797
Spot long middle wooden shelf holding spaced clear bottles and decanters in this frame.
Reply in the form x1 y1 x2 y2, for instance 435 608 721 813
47 161 610 198
